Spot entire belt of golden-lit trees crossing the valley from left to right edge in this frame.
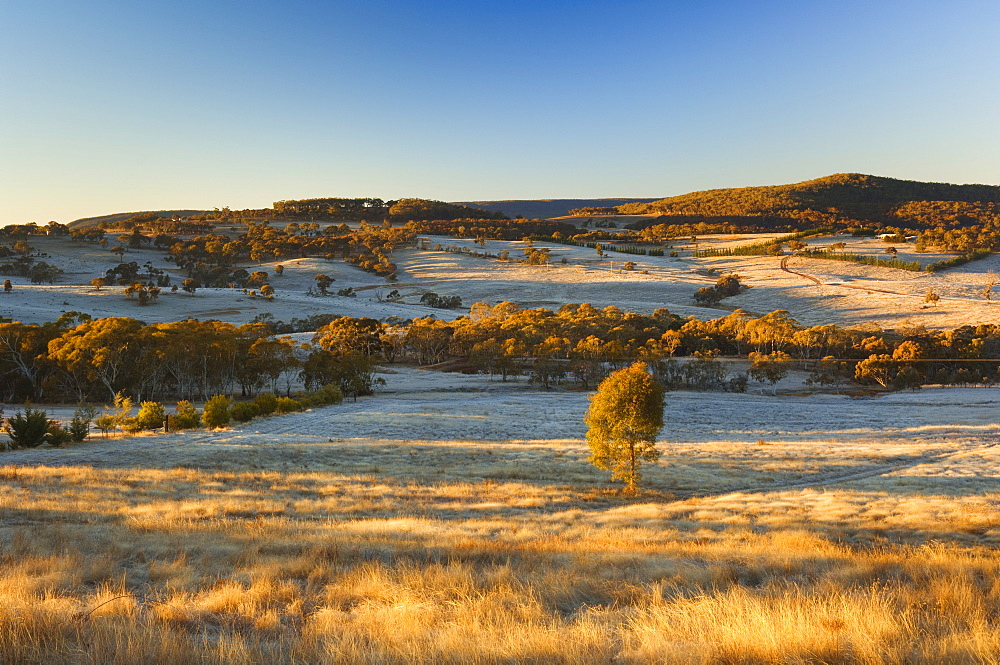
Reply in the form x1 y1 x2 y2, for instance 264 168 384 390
7 302 1000 402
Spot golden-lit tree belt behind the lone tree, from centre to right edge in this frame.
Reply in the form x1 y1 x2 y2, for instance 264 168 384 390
268 304 1000 390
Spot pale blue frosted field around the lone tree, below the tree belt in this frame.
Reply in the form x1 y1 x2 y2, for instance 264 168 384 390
7 369 1000 494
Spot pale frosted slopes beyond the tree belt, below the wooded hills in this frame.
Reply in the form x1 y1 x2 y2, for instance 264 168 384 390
11 234 1000 328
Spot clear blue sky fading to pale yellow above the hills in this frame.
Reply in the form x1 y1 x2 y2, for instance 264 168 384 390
0 0 1000 224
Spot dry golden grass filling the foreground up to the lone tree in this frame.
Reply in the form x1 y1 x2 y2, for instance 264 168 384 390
0 434 1000 665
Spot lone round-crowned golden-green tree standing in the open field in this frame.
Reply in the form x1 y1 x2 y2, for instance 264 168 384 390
583 362 665 494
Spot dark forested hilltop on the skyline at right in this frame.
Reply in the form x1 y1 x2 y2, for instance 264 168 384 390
612 173 1000 227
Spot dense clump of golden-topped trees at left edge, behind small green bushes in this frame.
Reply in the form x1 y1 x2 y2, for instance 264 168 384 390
0 312 376 402
